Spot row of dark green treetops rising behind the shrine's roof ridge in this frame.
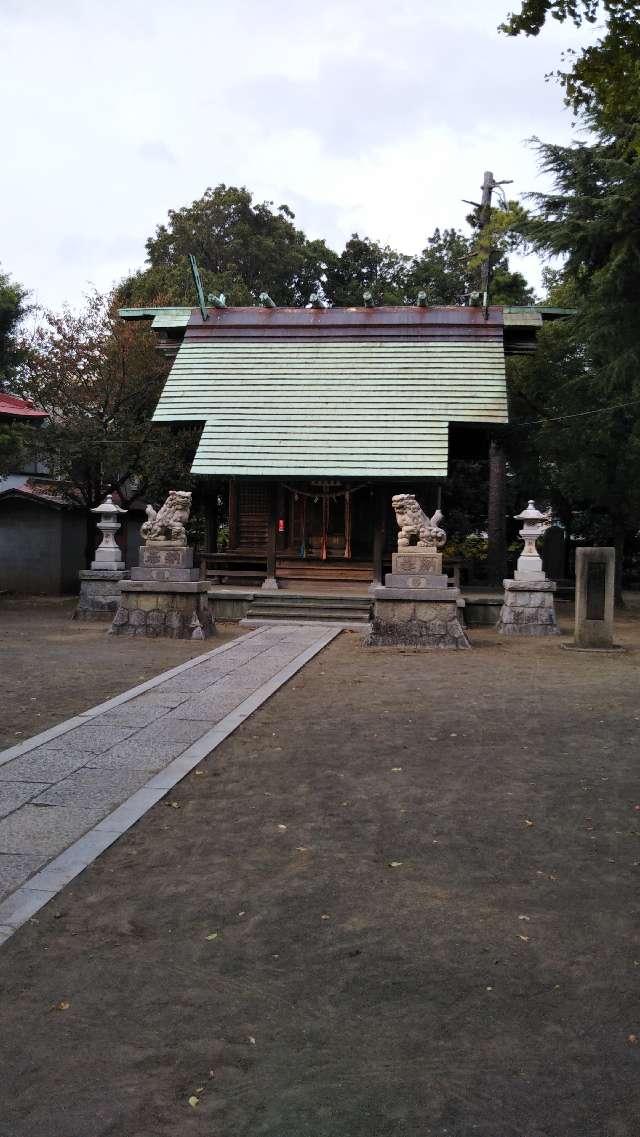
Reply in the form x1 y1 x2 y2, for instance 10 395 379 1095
117 185 534 307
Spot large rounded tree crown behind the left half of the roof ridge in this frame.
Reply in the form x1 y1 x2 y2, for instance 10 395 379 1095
118 184 336 305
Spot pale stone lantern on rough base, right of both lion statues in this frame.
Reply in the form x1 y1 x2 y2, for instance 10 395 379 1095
496 501 559 636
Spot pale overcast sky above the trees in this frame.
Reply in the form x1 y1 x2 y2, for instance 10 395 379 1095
0 0 595 307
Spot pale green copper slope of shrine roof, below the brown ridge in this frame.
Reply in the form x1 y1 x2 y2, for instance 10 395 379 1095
153 337 507 478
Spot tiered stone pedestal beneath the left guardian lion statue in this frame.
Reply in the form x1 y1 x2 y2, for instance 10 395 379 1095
110 542 215 639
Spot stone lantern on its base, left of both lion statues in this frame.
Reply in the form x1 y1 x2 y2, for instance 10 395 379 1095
74 493 128 620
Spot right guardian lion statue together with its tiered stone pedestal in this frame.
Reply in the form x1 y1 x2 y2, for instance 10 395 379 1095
366 493 471 648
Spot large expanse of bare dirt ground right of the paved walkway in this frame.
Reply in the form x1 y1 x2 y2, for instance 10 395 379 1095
0 617 640 1137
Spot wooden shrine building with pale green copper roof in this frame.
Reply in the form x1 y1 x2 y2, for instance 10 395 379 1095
120 305 560 588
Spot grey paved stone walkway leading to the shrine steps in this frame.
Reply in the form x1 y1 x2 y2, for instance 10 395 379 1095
0 624 341 943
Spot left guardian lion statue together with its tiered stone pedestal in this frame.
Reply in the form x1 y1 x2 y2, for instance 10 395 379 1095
111 490 215 639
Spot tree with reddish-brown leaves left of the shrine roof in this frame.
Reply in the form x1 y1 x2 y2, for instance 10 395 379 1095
17 292 198 559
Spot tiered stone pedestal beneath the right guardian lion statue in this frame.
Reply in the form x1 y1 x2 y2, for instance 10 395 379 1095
365 546 471 649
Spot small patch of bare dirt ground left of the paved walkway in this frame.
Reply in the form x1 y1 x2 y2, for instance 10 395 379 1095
0 598 238 749
